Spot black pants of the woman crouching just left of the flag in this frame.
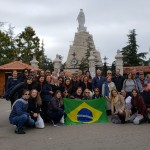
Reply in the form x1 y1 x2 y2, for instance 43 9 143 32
48 110 64 124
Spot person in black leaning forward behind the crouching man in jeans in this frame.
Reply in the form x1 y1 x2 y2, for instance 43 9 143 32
10 76 33 106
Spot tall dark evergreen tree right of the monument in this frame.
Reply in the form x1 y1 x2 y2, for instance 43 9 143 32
121 29 147 66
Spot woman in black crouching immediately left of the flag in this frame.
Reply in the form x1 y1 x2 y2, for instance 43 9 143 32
48 91 64 125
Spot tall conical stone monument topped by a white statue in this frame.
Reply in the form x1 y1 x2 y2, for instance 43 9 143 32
65 9 103 72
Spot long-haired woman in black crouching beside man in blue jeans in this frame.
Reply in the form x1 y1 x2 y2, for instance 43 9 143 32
28 89 42 121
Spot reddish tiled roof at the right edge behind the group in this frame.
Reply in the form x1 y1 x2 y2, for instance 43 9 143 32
123 66 150 74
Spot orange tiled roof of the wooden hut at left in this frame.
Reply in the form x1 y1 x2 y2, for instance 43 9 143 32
0 61 38 70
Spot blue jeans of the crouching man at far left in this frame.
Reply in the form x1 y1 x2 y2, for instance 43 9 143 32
10 114 35 130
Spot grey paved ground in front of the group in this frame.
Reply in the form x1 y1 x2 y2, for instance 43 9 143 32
0 99 150 150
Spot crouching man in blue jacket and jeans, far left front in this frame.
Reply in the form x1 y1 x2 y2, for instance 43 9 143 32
9 90 35 134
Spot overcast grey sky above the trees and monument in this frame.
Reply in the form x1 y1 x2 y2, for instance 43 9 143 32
0 0 150 64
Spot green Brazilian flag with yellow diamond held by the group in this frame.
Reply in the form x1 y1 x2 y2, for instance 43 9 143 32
64 98 108 125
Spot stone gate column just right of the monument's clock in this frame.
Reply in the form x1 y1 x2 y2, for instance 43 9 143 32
88 51 95 78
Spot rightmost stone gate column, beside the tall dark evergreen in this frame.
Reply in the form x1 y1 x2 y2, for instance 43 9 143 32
115 50 123 75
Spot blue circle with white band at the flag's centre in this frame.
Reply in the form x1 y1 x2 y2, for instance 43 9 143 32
77 108 93 122
